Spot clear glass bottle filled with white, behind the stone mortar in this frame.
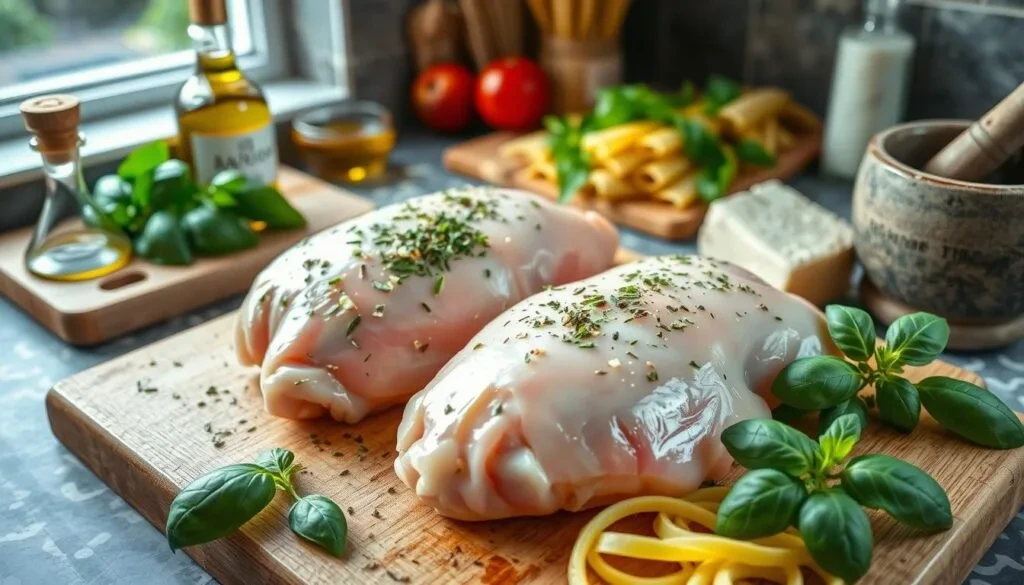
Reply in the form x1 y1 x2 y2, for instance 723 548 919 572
821 0 915 178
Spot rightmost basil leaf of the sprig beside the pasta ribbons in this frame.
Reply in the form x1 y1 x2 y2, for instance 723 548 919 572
842 455 953 531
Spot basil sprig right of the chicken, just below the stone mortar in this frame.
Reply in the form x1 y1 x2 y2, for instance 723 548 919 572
772 304 1024 449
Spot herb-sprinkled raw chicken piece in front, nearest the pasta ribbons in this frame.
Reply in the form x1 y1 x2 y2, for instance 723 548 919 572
395 256 835 520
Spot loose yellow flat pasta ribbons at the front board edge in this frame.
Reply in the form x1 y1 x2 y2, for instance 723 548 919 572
568 488 844 585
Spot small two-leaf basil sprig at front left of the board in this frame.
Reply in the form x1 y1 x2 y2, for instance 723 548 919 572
166 449 348 556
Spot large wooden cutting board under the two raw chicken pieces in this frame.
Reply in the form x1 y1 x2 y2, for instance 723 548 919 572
46 315 1024 585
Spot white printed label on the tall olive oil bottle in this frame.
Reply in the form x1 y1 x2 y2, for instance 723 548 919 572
191 124 278 184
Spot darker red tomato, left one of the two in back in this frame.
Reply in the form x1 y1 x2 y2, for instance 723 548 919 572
413 64 473 132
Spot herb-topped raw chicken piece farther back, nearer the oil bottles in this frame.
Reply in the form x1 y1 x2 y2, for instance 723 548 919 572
236 187 618 422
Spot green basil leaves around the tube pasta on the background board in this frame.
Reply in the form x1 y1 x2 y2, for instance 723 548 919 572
544 76 775 203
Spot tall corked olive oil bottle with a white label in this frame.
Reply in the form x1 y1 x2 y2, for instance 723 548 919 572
175 0 278 184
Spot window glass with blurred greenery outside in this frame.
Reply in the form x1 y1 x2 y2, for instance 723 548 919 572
0 0 252 100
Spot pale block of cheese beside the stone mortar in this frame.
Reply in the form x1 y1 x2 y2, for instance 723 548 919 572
697 180 853 305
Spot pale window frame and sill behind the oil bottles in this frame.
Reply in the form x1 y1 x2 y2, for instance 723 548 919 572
0 0 289 140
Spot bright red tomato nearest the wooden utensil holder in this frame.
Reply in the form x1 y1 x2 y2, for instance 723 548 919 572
476 57 550 130
